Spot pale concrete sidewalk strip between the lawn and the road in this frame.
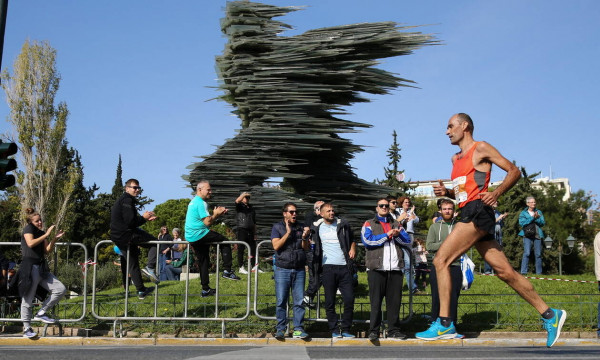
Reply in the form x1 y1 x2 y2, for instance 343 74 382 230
0 332 600 347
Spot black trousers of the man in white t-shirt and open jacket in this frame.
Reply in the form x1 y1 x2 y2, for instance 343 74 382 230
321 265 354 332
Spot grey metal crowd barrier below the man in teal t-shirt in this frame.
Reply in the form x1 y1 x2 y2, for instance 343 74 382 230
91 240 251 337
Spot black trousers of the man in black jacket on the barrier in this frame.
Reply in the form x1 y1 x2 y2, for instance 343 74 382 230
115 229 156 291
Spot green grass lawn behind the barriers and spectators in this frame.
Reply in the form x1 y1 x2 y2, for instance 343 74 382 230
4 272 600 336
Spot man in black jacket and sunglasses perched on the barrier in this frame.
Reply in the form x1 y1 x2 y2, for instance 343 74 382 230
110 179 159 299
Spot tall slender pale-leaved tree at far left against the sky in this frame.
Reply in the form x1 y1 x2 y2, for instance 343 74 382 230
2 41 81 227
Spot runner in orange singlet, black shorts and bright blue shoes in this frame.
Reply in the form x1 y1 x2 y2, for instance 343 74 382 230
416 113 567 347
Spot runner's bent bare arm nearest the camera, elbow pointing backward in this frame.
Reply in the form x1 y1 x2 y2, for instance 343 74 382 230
473 141 521 206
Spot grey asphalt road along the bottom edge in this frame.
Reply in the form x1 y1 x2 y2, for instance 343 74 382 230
0 345 600 360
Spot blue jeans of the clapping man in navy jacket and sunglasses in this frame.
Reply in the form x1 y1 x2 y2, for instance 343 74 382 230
275 266 306 331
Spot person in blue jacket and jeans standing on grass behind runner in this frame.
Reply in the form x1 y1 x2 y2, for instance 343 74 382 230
519 196 546 275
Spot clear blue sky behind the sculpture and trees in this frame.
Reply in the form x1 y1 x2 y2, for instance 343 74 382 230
0 0 600 205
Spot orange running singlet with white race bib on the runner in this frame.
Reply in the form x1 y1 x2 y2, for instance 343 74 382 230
451 141 490 208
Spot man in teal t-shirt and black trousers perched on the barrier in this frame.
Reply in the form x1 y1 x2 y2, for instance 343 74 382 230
185 180 240 296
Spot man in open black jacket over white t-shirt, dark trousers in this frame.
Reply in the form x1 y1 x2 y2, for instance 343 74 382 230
310 203 356 338
